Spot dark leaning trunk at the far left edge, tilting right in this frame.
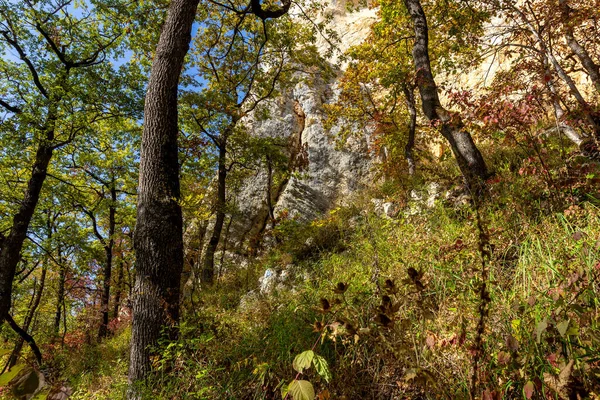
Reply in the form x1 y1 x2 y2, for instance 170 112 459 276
0 103 58 324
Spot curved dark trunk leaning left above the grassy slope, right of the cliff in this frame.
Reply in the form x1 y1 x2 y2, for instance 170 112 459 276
404 0 487 192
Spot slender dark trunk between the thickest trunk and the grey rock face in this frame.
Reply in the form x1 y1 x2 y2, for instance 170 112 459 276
201 141 227 285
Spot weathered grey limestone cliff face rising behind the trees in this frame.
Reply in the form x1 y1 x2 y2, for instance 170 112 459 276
232 0 376 246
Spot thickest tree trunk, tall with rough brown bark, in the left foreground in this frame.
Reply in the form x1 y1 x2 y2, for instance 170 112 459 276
128 0 199 399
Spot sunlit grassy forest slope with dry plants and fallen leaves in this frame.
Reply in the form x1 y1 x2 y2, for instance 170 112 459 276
41 142 600 400
